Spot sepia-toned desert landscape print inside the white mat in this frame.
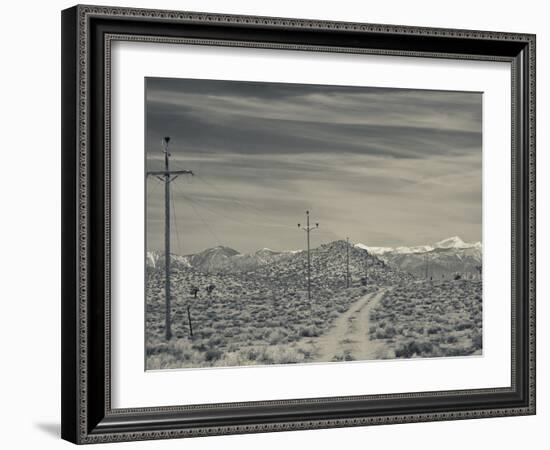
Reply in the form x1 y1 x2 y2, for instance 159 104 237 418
145 78 483 370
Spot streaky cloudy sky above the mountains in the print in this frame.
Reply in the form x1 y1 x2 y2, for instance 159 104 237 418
145 78 482 254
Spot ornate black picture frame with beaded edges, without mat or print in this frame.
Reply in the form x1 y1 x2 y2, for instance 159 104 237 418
62 6 535 444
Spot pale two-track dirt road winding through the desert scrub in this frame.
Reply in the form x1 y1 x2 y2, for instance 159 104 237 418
313 289 386 362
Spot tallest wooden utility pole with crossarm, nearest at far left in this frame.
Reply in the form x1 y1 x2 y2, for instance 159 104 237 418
146 136 194 341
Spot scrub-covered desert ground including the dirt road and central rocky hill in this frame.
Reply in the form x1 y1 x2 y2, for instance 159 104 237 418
145 241 482 370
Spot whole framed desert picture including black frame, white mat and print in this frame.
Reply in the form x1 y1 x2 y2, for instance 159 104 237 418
62 6 535 444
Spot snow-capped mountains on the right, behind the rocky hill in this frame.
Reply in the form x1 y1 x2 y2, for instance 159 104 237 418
356 236 482 278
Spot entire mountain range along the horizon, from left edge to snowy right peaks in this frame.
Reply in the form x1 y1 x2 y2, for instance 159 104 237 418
147 236 482 278
